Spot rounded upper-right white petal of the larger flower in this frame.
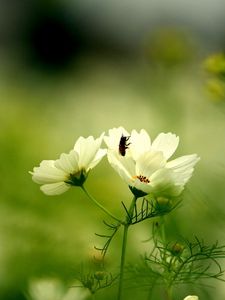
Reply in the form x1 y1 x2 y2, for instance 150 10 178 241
152 132 179 159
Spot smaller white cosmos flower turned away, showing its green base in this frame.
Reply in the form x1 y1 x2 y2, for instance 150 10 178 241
30 133 106 195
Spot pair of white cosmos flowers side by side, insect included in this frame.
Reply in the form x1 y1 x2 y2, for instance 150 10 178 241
30 127 199 197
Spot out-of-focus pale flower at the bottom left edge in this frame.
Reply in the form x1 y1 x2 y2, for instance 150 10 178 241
28 278 90 300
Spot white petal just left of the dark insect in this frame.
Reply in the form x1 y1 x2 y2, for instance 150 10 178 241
104 126 130 152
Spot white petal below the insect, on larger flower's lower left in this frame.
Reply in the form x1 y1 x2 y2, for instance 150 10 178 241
108 151 135 184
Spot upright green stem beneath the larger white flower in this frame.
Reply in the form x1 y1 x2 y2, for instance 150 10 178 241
117 197 137 300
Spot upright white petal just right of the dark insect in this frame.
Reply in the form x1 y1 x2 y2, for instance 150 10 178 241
129 129 151 160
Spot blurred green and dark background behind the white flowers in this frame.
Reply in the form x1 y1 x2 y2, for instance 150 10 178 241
0 0 225 300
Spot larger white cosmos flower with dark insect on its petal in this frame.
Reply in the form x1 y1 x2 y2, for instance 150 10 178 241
104 127 199 197
